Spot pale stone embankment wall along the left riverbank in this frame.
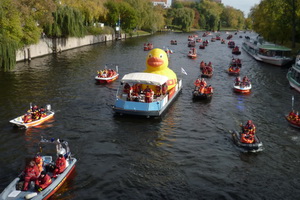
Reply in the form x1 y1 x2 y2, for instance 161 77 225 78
16 34 126 62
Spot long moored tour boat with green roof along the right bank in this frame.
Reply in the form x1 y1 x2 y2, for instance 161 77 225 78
242 37 293 66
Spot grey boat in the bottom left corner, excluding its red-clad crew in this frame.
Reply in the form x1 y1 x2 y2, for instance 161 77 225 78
0 139 77 200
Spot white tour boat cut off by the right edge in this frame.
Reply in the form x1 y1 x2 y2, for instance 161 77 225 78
286 55 300 92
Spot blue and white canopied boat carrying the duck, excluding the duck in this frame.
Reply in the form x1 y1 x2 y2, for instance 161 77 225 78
113 72 182 117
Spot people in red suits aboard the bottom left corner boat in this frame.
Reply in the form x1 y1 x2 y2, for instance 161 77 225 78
22 154 67 192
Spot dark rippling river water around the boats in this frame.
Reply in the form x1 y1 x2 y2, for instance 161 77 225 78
0 32 300 200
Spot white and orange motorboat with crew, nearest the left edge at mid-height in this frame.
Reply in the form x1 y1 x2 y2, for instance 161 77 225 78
9 104 54 128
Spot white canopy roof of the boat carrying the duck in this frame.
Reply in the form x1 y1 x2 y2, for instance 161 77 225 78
121 72 168 85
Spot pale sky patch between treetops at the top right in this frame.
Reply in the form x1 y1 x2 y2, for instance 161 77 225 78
222 0 260 17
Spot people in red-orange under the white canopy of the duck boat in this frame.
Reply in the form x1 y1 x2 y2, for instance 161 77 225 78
123 83 168 103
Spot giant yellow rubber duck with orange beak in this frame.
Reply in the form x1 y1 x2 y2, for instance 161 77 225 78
144 48 177 90
